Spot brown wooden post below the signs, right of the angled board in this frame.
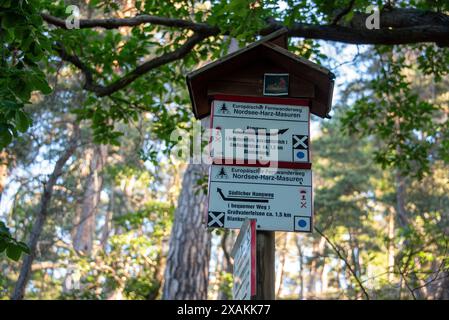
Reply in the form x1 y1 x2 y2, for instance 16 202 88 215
256 230 275 300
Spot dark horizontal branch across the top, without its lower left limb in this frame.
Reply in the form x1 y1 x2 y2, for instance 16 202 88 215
41 8 449 46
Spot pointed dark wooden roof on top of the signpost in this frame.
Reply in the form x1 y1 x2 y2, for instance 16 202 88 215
186 28 335 119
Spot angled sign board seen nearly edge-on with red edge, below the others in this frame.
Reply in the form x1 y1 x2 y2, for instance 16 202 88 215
231 220 256 300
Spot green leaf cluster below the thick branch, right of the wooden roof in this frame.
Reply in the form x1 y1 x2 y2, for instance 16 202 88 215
342 48 440 179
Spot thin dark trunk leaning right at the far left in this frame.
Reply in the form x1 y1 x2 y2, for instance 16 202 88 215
11 128 78 300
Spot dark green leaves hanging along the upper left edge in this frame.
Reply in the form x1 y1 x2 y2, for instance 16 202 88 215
0 0 51 149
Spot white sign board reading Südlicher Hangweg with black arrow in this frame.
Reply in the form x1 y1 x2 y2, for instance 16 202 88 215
207 165 313 232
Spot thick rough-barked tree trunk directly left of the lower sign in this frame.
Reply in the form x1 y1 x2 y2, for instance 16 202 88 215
163 164 211 300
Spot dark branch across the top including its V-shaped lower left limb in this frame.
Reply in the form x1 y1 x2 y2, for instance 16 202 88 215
41 6 449 97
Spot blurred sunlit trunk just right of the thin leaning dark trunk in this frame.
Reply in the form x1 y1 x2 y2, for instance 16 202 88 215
73 145 107 255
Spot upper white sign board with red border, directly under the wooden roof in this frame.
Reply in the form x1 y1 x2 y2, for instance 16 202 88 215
211 100 310 163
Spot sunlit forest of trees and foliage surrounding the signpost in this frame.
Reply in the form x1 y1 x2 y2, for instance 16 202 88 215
0 0 449 299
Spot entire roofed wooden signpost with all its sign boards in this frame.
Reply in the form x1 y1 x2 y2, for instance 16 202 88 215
187 29 335 299
